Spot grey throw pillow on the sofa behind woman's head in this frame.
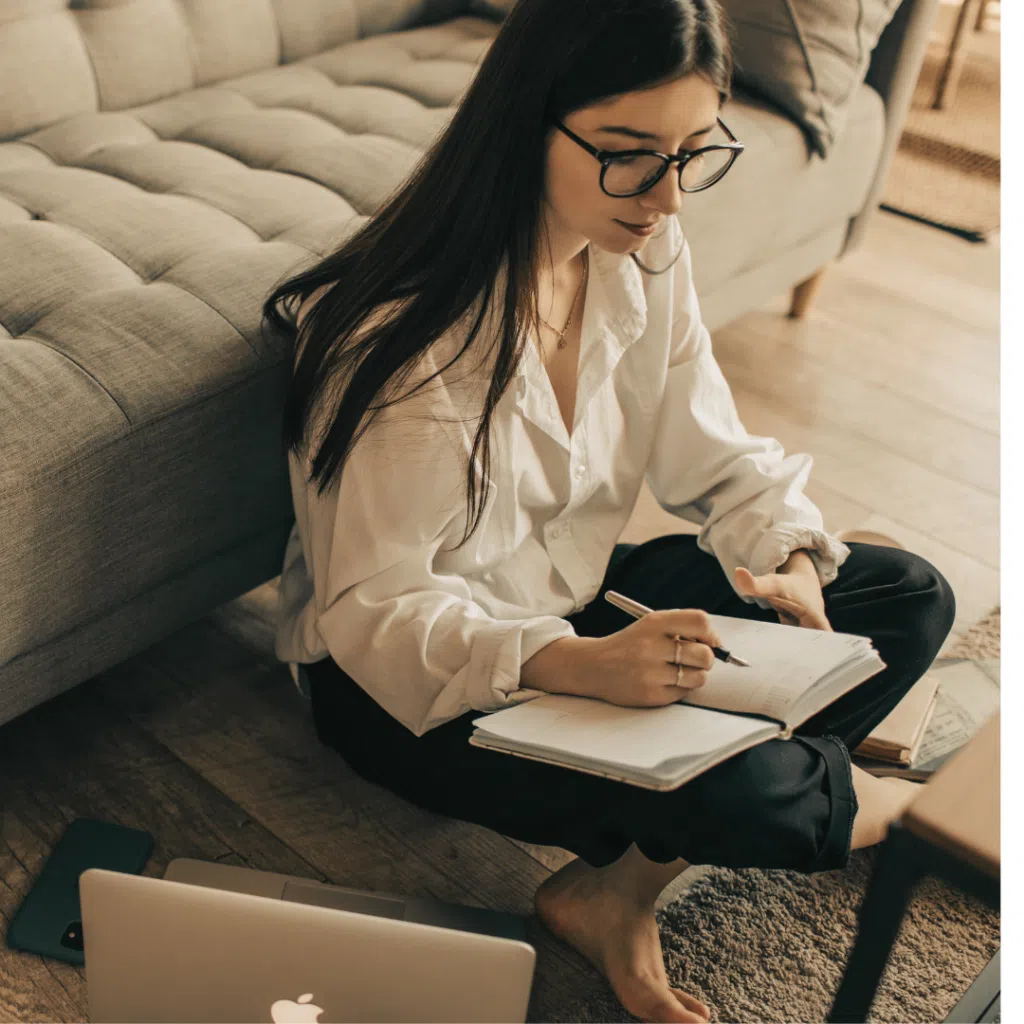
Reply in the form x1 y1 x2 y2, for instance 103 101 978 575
722 0 900 157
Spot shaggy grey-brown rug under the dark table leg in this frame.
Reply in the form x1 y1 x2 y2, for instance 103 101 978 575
557 609 999 1024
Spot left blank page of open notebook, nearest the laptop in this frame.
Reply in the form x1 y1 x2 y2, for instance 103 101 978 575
473 693 765 769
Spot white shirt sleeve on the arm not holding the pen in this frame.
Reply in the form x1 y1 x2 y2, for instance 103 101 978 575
646 232 850 608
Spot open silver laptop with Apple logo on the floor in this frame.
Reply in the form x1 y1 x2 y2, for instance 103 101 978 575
79 858 536 1024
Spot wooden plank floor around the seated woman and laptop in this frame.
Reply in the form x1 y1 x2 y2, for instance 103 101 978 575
0 205 999 1021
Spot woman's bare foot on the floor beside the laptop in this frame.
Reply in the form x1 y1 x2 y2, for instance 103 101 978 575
534 858 711 1024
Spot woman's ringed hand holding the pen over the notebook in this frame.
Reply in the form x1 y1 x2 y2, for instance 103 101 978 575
571 608 722 708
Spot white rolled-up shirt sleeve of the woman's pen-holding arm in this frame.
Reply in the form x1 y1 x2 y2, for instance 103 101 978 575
301 366 575 736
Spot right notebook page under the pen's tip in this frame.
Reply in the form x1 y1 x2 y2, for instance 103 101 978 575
683 615 870 720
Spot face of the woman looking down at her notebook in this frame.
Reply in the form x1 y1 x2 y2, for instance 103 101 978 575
545 75 720 253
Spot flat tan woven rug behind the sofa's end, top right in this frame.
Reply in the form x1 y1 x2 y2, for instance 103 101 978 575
883 4 1000 242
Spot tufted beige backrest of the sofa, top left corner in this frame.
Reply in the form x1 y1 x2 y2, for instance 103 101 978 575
0 0 466 139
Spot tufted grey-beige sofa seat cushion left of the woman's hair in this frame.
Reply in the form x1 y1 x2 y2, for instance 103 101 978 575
0 17 494 666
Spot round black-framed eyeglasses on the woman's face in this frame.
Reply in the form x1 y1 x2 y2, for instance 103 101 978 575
551 118 744 199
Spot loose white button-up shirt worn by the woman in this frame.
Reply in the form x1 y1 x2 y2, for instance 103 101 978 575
275 217 850 735
